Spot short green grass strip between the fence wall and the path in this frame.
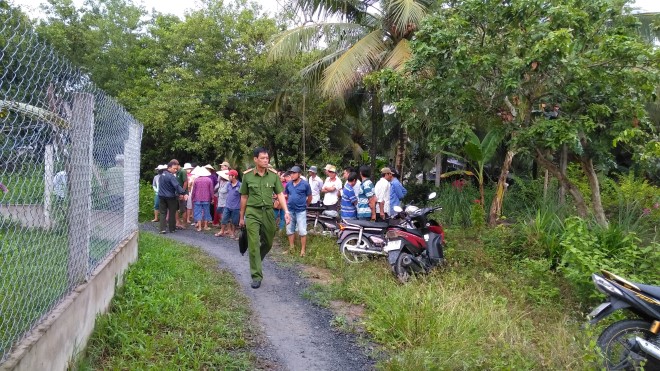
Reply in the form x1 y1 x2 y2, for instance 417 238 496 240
78 233 255 370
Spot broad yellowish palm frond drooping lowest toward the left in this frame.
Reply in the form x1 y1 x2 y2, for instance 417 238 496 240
321 30 387 97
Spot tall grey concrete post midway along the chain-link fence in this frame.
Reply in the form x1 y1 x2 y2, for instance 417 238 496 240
67 93 94 287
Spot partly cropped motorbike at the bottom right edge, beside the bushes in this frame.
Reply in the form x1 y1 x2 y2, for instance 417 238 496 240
589 270 660 370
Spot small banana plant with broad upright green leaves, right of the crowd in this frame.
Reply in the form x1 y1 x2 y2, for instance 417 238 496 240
440 130 502 207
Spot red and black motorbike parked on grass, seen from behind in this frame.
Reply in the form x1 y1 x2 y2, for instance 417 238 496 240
384 192 445 283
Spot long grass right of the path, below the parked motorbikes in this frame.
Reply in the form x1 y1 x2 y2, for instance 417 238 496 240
282 230 598 370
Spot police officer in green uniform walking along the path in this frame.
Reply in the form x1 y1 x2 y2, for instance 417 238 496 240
239 147 291 289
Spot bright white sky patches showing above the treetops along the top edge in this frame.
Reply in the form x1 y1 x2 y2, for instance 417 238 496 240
9 0 660 17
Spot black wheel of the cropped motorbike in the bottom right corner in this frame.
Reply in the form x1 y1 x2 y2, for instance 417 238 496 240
597 320 657 370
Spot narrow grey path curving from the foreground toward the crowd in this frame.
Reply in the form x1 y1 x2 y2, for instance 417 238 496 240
141 223 374 371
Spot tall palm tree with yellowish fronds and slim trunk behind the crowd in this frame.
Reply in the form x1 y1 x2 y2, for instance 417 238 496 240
270 0 434 166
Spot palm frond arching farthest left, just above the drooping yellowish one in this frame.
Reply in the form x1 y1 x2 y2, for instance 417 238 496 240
268 22 365 61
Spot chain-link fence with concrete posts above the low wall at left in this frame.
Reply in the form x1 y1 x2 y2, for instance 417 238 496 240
0 5 142 363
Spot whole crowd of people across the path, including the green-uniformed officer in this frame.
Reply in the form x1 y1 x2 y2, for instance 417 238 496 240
152 147 407 288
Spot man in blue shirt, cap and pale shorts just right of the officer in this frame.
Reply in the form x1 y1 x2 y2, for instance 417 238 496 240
284 166 312 256
